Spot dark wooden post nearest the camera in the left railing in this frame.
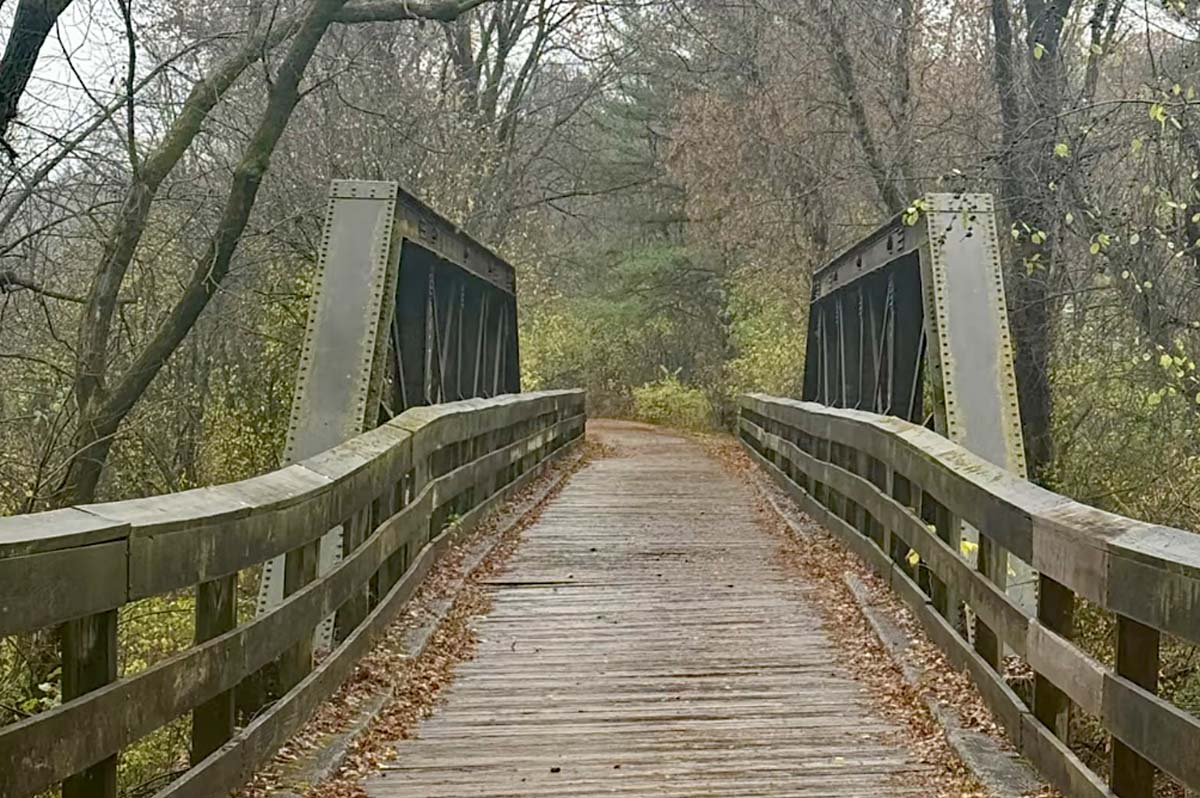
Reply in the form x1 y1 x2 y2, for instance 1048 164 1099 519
61 610 116 798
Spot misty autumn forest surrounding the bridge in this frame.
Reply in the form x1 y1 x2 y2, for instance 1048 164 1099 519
0 0 1200 794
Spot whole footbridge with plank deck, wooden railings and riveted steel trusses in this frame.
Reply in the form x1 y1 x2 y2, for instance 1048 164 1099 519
0 181 1200 798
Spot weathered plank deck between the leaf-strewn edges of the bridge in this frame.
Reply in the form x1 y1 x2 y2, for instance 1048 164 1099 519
366 422 926 798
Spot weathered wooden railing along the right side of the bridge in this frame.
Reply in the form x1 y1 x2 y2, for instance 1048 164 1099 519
739 395 1200 798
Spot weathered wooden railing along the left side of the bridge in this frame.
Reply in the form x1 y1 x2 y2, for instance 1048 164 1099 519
0 391 584 798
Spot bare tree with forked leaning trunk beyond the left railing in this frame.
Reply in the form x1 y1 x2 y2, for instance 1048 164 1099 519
0 0 485 503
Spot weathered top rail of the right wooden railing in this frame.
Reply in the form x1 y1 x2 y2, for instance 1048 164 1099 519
740 395 1200 642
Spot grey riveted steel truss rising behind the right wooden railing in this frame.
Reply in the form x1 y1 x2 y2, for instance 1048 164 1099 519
804 193 1036 607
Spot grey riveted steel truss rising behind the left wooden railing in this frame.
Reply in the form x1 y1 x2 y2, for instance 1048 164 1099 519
258 180 521 647
